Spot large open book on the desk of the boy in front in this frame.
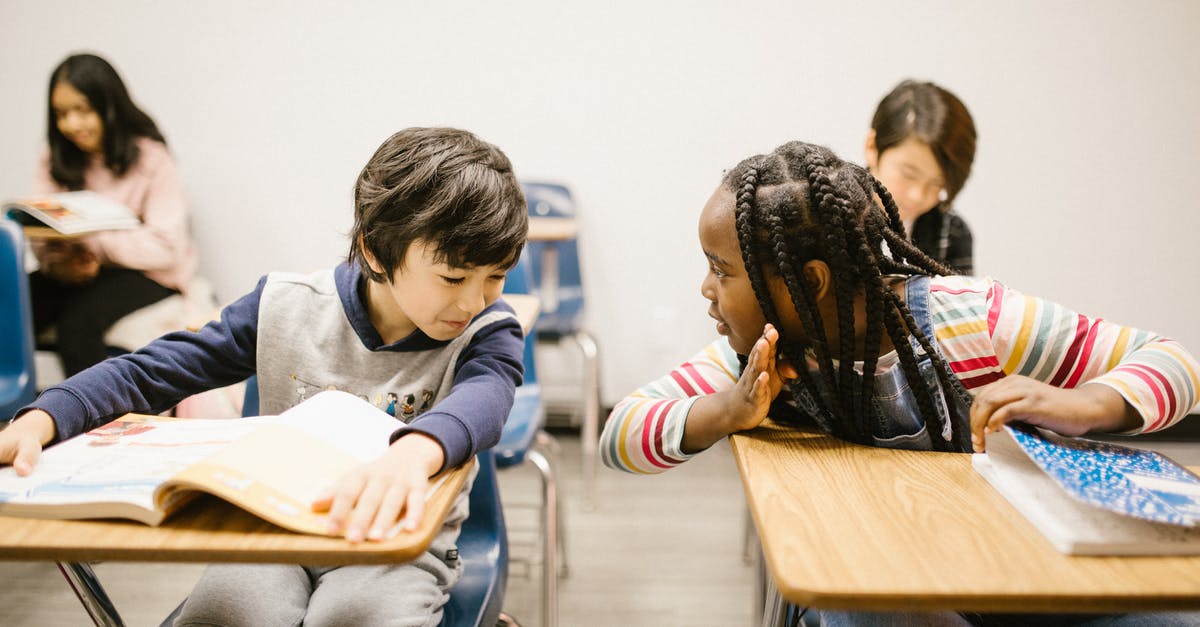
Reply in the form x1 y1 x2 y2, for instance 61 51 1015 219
0 390 437 536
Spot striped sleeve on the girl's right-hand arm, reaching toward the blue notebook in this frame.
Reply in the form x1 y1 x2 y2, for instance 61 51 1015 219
930 276 1200 432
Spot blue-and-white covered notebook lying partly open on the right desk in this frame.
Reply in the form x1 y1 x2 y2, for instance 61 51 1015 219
972 425 1200 555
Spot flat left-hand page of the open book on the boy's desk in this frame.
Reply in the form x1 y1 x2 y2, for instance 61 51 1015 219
0 414 262 525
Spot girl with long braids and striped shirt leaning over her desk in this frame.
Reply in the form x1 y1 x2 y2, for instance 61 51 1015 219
600 142 1200 473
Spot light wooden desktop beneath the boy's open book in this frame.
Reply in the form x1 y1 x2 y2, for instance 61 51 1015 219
0 462 474 565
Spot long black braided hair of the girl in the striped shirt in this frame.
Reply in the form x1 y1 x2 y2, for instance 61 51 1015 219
725 142 971 452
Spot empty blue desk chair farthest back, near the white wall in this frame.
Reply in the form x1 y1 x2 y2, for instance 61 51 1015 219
521 181 600 509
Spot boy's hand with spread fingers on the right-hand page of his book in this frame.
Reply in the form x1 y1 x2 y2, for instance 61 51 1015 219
312 432 445 542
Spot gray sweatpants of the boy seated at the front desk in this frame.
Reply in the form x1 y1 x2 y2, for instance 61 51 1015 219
175 466 474 627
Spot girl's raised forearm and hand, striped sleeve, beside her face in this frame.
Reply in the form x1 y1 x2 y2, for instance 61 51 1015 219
600 326 793 473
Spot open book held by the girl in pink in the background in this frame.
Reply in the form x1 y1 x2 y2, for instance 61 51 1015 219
4 191 142 238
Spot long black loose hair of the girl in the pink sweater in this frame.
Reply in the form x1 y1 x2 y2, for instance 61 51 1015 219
46 54 167 190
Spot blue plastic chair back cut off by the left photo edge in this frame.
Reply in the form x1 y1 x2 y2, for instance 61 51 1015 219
0 220 37 423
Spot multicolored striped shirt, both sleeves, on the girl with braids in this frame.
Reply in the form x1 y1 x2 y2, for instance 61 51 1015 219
600 276 1200 473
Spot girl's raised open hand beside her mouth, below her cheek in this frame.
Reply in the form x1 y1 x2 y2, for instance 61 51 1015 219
721 324 797 432
